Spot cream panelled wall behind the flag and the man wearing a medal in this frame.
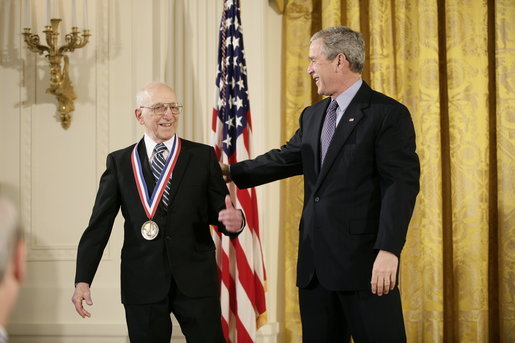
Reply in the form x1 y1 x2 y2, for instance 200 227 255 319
0 0 281 343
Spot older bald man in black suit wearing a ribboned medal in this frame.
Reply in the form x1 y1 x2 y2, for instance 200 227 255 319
72 83 244 343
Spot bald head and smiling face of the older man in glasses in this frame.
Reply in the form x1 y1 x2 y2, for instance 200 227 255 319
134 83 179 143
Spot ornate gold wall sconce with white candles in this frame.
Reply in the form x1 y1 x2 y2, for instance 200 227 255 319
22 0 91 129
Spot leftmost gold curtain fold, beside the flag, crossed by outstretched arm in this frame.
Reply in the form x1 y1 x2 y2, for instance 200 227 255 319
281 0 313 342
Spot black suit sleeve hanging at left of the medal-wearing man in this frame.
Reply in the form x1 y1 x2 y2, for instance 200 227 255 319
75 154 120 285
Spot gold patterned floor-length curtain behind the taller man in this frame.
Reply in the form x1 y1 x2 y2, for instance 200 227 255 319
276 0 515 343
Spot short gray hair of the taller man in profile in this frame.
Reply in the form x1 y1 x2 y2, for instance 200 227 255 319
310 26 365 73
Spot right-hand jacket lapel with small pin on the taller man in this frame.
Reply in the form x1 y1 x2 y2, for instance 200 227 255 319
315 81 371 191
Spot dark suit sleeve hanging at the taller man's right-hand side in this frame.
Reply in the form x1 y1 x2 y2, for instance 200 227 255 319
374 105 420 256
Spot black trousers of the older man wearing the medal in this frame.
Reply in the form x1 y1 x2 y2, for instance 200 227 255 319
124 281 225 343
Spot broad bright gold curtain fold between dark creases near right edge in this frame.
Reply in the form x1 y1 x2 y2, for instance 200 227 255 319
443 1 493 342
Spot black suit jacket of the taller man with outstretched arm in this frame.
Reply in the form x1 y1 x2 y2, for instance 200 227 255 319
230 82 420 291
